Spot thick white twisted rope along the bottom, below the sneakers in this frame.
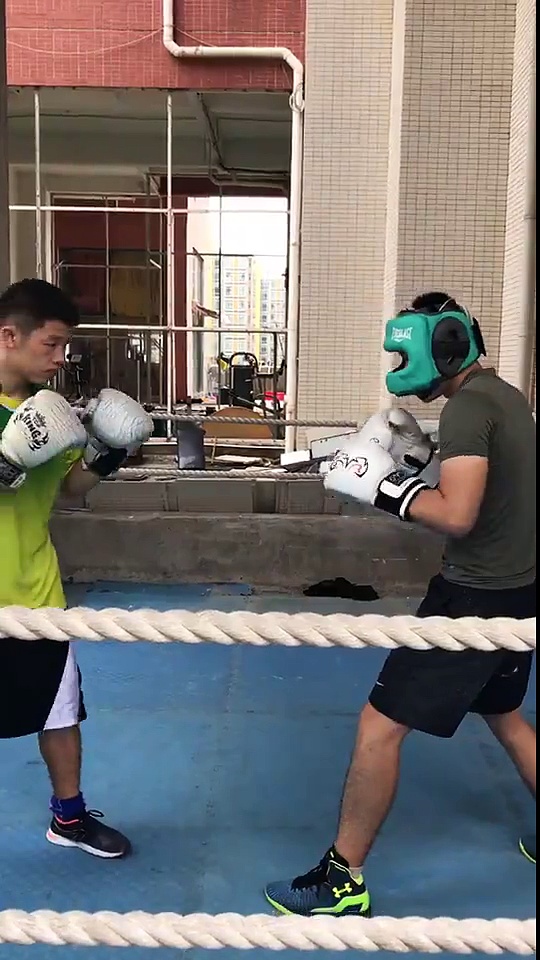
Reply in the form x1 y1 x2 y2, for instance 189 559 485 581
0 910 536 956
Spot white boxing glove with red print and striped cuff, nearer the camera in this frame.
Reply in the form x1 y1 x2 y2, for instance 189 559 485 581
323 442 429 520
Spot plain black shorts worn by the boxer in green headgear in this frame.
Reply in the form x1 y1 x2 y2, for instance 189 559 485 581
369 574 536 737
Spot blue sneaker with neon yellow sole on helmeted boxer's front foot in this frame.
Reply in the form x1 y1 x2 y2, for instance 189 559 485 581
264 847 371 917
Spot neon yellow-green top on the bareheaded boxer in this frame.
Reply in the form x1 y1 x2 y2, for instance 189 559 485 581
0 393 81 609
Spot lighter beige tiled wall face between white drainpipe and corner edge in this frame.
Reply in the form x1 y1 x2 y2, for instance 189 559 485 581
299 0 393 430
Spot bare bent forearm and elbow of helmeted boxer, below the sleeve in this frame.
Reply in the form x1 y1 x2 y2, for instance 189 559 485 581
409 456 488 537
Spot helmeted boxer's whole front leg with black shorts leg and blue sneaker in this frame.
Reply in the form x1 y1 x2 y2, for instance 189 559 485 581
265 647 498 916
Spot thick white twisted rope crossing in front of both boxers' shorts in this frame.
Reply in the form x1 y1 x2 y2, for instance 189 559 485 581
0 606 536 653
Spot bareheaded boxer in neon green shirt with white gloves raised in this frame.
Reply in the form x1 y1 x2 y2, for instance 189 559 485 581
0 280 152 859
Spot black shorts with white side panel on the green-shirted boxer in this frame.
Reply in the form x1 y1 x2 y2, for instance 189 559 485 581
0 637 86 740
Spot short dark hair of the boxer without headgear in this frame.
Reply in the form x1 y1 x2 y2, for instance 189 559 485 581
0 278 80 334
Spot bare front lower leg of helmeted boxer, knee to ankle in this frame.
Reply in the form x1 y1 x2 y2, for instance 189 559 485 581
335 703 410 873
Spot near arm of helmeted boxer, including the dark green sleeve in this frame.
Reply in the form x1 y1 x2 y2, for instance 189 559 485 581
409 390 494 537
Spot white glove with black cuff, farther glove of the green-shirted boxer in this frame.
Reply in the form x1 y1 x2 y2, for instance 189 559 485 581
82 387 154 477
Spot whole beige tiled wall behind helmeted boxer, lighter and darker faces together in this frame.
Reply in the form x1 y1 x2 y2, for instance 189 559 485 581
299 0 533 432
